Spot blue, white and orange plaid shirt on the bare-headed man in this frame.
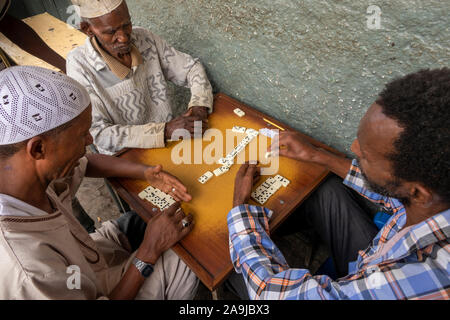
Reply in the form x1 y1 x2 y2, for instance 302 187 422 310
228 160 450 300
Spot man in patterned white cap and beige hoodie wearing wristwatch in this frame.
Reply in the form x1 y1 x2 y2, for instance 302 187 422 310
0 66 198 299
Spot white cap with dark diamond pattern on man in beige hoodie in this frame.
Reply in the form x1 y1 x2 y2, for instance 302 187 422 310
0 66 90 145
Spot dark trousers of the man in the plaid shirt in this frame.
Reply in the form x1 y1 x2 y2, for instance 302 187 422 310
226 175 378 299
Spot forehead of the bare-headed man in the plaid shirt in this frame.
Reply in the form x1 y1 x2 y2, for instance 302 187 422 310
358 103 403 158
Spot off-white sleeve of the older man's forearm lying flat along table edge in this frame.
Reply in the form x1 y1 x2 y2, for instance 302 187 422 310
66 54 165 154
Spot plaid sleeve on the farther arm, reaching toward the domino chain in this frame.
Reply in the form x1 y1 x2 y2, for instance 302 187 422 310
343 159 404 214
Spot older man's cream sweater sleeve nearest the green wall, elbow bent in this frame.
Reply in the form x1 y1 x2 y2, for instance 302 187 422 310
147 31 213 112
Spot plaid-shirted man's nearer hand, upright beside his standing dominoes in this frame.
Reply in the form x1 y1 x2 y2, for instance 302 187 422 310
233 162 261 208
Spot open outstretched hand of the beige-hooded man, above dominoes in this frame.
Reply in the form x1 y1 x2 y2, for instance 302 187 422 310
144 165 192 202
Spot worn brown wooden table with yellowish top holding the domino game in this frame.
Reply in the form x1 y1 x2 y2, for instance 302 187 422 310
110 94 337 291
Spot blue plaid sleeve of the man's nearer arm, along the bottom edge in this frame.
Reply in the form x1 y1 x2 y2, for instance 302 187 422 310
227 205 422 300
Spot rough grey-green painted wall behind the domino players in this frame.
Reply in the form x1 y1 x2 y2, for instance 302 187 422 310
127 0 450 154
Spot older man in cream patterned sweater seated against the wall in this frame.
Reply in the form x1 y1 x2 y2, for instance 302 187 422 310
67 0 213 154
